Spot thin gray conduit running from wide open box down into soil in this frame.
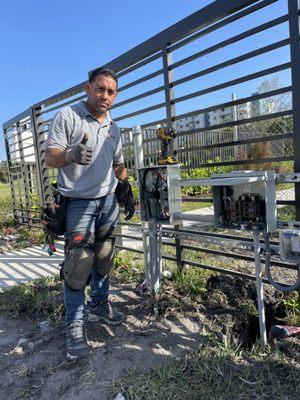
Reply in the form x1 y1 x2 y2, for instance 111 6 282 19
253 229 267 346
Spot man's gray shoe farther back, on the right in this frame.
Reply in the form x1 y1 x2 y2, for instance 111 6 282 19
87 300 125 325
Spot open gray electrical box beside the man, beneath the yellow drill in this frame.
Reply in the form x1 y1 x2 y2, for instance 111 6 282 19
138 164 182 224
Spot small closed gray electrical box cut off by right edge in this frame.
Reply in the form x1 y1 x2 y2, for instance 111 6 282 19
279 229 300 264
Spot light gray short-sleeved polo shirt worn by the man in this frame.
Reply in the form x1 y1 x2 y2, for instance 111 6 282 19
46 101 124 199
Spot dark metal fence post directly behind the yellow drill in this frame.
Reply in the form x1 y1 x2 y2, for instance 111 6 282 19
162 47 183 272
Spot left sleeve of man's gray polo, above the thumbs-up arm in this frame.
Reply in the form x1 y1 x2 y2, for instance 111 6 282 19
46 111 70 150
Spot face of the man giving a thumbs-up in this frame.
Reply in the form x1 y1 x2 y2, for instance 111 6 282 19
86 75 117 115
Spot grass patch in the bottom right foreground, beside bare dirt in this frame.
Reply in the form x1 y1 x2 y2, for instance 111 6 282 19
114 343 300 400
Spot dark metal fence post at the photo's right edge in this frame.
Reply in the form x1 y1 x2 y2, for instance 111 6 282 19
288 0 300 221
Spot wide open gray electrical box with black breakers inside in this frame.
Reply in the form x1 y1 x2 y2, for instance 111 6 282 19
211 171 277 232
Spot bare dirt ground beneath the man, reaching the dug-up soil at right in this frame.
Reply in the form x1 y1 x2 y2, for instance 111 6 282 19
0 276 300 400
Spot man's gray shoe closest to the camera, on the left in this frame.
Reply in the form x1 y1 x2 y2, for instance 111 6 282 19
67 321 91 361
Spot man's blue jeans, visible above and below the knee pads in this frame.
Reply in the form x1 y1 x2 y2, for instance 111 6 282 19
64 193 119 324
